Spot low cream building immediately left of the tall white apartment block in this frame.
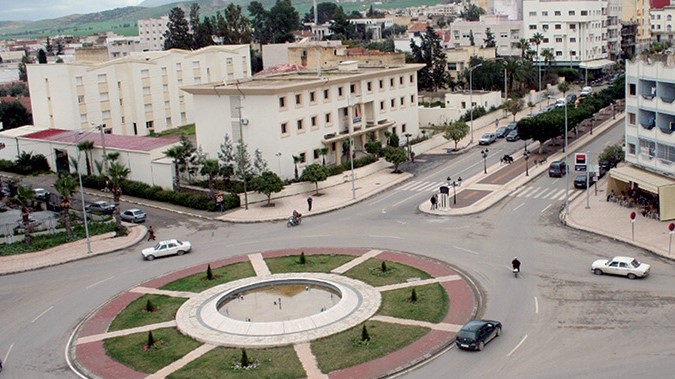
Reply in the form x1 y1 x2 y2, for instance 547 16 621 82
449 15 522 56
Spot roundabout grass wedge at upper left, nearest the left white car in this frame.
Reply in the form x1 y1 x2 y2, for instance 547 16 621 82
161 261 255 292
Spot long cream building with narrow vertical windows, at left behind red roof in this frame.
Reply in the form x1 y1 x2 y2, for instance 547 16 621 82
27 45 251 136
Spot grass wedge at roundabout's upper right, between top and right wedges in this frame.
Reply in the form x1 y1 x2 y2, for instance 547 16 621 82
344 258 431 287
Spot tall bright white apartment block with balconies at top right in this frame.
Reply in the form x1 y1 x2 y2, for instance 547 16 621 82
523 0 609 68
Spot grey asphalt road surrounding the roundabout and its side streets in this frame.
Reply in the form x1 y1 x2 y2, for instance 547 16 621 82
0 122 675 379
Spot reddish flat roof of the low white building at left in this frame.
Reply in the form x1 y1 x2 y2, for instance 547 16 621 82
23 129 178 151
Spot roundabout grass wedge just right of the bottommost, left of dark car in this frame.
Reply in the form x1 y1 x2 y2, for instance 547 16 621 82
312 321 429 373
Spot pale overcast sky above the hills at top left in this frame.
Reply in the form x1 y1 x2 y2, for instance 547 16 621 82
0 0 143 21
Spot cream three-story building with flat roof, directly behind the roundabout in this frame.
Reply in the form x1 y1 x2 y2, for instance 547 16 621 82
183 62 423 178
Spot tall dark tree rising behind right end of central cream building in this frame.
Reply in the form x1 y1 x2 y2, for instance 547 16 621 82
410 25 449 91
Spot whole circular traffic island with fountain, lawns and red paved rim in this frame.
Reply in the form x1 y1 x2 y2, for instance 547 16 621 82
68 248 478 378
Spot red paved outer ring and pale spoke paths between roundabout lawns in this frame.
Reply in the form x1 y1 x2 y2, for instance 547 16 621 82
68 248 480 379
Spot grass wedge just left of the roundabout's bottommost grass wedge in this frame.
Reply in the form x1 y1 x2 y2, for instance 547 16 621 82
103 328 201 374
